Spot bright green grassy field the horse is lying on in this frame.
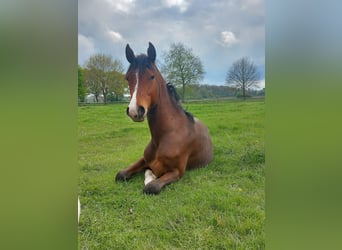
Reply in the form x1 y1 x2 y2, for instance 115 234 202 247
78 100 265 249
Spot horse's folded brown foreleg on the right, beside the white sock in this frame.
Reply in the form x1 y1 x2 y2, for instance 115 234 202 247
144 168 181 194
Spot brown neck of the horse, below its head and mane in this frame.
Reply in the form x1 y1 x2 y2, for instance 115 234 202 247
148 82 185 141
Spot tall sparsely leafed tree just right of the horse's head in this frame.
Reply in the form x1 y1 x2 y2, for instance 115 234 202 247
161 43 204 102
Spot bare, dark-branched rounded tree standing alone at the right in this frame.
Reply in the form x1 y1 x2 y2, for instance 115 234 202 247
226 57 259 99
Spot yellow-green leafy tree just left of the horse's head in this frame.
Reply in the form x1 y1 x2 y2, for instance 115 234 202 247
84 53 124 103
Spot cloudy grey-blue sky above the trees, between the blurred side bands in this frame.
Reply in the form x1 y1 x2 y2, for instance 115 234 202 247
78 0 265 87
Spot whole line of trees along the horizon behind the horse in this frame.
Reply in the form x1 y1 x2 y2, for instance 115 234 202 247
78 43 265 103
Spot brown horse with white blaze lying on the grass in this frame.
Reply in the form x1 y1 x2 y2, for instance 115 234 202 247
115 43 213 194
